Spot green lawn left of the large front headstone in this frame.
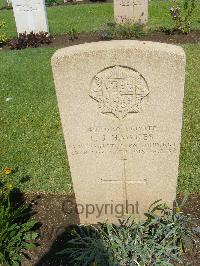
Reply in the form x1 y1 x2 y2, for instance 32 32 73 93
0 49 71 192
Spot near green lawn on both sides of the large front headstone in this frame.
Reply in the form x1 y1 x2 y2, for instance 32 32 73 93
0 44 200 193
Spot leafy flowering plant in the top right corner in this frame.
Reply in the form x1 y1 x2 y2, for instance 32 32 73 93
170 0 197 34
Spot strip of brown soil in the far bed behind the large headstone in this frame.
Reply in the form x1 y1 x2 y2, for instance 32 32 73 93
2 31 200 51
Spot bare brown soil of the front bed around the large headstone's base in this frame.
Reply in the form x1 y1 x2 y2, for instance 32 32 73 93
20 194 200 266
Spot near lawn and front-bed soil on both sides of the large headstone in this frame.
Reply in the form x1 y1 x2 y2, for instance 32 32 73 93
0 44 200 265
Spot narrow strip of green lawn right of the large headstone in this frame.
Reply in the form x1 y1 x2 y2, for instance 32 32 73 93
179 44 200 192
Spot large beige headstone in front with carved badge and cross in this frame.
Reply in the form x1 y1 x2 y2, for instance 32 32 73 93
52 40 185 223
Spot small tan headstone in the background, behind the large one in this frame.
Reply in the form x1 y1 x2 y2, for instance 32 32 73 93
114 0 148 25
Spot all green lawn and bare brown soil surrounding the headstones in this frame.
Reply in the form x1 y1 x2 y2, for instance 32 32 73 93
0 1 200 266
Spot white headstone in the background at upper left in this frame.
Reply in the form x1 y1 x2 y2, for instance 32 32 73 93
12 0 49 34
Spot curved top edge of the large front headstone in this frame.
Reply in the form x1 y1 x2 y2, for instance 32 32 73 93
51 40 186 65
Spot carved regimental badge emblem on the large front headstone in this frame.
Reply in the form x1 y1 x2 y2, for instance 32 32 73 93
89 66 149 119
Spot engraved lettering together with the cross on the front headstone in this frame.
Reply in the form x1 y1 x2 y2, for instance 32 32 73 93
69 123 178 205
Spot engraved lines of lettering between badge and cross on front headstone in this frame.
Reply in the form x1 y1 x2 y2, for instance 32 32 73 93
69 125 178 157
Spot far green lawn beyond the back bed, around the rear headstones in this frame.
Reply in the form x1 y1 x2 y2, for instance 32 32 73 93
0 0 200 37
